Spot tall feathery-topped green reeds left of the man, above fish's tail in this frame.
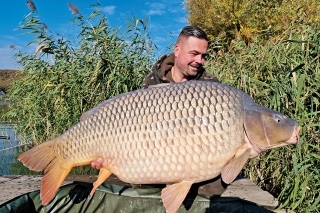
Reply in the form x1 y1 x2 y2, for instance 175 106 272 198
5 1 154 143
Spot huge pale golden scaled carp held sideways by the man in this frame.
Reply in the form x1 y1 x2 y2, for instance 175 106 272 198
18 81 300 213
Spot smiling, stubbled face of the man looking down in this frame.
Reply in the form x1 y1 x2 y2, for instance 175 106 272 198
174 36 208 78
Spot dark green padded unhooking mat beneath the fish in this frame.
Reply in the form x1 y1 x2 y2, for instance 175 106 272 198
0 182 272 213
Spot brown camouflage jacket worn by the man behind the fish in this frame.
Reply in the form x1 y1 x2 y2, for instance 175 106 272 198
141 53 219 88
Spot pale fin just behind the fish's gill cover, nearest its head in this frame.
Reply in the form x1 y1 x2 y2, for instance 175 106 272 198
221 144 251 184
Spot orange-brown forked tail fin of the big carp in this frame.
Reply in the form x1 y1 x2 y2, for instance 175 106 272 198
18 139 73 205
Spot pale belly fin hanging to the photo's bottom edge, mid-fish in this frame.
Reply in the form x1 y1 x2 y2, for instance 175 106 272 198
161 180 193 213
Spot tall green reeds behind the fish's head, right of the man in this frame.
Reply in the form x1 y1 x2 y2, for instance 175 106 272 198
207 23 320 212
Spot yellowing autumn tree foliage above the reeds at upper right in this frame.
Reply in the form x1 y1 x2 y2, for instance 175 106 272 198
185 0 320 44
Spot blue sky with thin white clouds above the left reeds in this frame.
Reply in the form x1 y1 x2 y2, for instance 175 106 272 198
0 0 188 69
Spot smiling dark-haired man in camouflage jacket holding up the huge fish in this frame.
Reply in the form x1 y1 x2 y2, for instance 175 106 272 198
91 26 226 196
